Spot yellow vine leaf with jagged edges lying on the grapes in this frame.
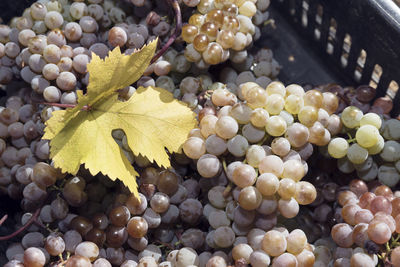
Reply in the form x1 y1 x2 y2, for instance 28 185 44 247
43 42 196 196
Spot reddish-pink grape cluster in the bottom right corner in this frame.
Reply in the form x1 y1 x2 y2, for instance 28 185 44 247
331 180 400 266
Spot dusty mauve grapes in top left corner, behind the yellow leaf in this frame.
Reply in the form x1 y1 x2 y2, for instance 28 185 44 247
0 0 178 104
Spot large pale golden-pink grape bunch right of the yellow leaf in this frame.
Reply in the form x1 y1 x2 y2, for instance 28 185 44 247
183 82 341 224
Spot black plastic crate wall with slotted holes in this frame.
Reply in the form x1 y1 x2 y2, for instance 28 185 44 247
261 0 400 116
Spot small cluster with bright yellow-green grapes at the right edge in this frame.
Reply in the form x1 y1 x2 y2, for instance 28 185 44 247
327 103 400 187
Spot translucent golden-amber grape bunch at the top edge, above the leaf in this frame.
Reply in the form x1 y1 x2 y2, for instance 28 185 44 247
182 0 269 66
